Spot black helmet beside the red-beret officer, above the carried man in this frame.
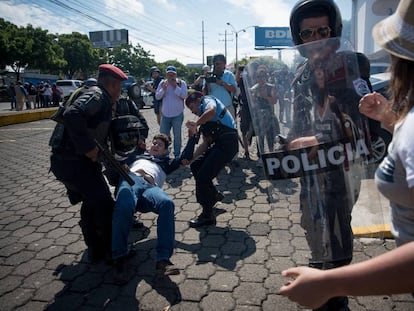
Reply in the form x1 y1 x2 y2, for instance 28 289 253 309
110 115 141 159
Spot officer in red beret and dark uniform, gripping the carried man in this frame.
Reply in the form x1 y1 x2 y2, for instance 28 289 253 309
51 64 127 262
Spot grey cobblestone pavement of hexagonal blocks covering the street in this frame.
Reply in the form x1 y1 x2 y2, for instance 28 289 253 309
0 110 414 311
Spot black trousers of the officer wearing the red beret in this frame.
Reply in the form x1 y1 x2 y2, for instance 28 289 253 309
51 154 114 259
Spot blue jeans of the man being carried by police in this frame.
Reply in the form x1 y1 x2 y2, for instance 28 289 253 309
112 173 175 261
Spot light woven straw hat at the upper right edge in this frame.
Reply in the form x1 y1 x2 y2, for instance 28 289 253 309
372 0 414 61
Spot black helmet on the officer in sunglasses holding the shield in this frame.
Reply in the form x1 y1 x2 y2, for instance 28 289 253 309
290 0 342 45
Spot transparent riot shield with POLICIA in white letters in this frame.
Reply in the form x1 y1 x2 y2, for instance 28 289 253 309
243 38 385 267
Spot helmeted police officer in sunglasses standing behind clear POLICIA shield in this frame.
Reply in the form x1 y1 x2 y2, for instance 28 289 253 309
288 0 369 310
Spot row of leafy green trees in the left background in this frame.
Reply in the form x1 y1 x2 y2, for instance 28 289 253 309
0 18 194 83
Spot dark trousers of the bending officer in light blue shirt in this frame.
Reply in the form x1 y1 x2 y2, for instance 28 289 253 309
191 131 239 216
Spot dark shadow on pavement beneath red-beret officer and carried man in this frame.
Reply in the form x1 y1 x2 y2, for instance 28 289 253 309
47 227 181 311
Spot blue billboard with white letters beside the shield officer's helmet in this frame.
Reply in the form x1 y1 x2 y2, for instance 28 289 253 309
255 27 293 50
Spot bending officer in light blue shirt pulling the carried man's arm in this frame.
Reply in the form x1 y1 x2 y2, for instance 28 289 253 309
185 91 239 228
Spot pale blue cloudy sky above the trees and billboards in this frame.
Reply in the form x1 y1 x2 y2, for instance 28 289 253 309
0 0 352 64
